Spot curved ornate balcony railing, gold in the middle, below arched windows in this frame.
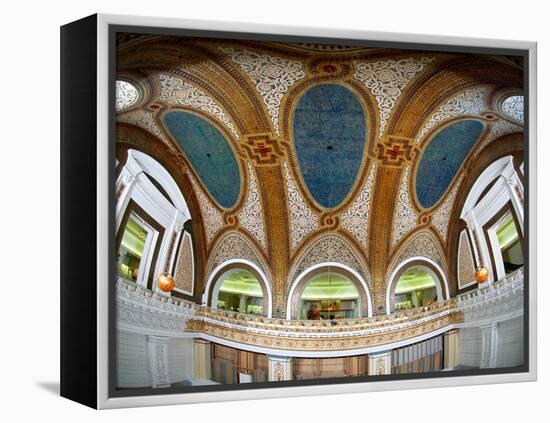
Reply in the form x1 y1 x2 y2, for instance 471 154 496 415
117 268 524 350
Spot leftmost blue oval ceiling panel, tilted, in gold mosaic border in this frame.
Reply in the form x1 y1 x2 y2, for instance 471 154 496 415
164 111 241 208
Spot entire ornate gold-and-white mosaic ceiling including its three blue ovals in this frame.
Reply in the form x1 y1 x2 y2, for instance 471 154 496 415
117 34 523 313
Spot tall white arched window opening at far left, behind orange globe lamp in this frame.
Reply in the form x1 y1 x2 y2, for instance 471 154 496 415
115 149 195 297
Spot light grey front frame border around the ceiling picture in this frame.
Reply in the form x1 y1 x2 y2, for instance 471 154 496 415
97 14 537 409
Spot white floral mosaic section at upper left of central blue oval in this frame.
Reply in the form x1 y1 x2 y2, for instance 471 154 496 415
220 47 306 135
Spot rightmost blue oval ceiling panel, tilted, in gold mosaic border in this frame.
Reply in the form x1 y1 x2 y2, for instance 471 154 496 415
416 120 483 208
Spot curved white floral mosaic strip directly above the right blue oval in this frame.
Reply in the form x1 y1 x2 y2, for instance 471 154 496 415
416 87 487 144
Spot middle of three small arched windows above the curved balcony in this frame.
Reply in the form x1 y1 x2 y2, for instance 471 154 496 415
298 272 360 320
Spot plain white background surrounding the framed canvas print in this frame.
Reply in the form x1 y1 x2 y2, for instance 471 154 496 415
0 0 550 423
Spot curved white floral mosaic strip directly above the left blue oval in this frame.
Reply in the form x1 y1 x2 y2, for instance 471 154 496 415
158 74 239 139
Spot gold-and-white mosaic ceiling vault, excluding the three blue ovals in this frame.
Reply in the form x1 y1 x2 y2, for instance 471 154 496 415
117 34 522 310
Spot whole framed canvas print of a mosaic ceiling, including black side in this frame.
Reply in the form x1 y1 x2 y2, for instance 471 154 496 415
61 15 536 408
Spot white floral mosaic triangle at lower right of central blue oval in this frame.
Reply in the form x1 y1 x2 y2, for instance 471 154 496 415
340 162 376 248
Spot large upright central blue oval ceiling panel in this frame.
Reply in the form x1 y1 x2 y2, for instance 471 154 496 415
293 84 367 208
